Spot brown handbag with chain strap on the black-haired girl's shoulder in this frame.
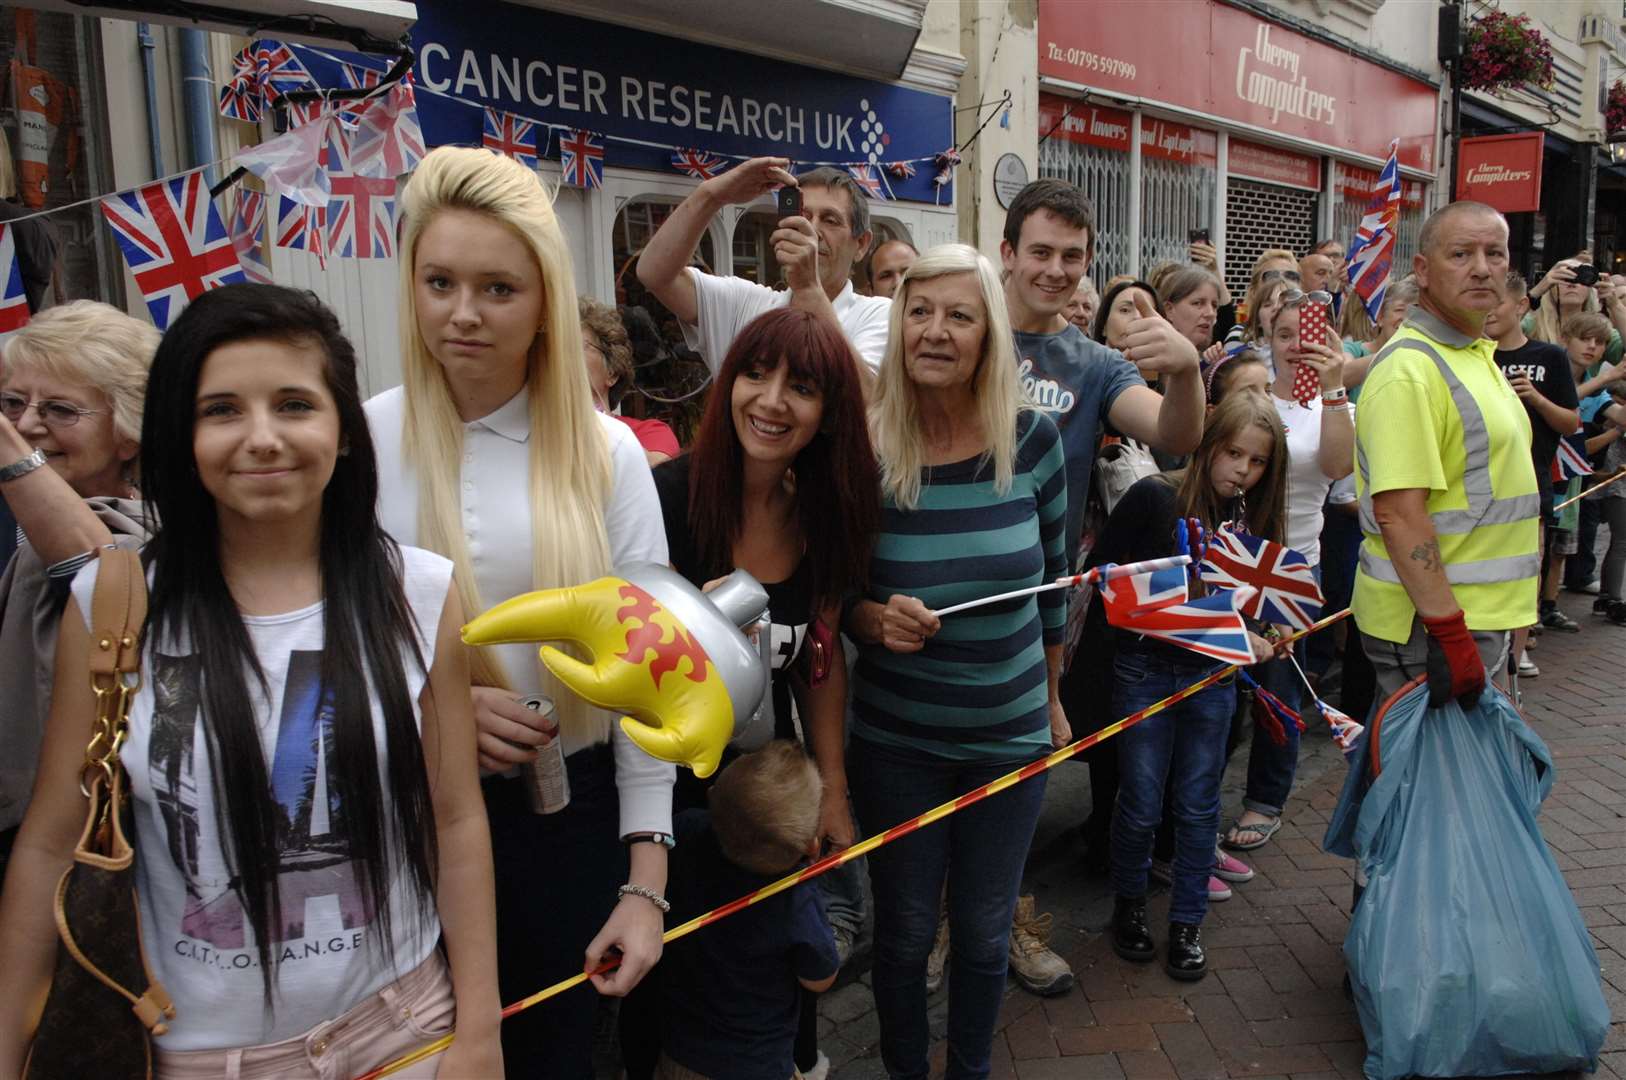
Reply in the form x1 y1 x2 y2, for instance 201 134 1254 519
23 547 176 1080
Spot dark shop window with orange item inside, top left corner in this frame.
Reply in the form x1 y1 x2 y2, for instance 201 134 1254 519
0 8 122 306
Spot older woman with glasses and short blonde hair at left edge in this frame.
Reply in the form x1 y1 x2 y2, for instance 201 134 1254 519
0 299 158 869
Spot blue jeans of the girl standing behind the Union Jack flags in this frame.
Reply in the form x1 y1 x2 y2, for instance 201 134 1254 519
1112 649 1236 923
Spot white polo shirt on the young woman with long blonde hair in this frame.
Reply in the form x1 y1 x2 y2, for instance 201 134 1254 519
366 387 676 836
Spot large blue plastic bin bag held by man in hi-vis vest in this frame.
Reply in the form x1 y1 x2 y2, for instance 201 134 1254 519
1325 682 1610 1080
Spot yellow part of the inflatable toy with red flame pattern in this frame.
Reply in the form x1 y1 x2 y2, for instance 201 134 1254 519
463 577 733 777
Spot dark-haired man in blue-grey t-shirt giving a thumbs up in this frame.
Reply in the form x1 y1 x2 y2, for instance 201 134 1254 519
982 179 1206 994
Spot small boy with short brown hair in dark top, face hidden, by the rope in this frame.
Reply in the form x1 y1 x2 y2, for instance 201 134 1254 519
655 740 841 1080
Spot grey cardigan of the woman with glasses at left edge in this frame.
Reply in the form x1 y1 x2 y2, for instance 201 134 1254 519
0 498 146 831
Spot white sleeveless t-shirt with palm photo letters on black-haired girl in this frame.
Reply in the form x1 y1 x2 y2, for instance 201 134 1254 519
73 548 452 1051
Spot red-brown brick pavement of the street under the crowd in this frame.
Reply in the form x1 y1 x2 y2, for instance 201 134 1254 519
821 594 1626 1080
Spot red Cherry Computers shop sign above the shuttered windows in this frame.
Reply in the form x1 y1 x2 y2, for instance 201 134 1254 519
1039 0 1439 172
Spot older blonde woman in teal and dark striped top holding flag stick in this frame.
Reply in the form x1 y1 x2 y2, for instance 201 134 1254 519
846 244 1070 1077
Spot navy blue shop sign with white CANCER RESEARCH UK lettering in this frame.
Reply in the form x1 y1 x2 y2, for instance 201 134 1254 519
411 0 954 202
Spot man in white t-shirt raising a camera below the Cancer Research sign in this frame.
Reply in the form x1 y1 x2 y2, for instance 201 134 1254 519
637 158 891 374
